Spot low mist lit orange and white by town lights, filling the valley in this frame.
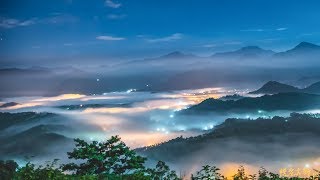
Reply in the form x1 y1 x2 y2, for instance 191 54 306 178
0 88 319 176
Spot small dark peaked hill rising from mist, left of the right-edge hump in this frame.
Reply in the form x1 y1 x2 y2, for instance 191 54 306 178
249 81 300 94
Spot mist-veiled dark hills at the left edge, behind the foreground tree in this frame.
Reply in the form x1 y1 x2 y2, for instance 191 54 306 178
0 112 73 158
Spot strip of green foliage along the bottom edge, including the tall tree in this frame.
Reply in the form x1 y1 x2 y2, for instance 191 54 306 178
0 136 320 180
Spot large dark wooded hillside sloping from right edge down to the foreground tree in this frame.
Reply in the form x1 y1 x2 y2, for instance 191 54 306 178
136 113 320 164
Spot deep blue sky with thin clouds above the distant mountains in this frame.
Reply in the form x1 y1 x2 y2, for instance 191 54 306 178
0 0 320 65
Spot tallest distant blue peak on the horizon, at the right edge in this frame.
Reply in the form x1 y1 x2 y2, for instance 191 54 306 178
275 42 320 58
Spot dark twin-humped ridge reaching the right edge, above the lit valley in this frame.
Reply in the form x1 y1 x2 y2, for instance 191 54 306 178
249 81 320 94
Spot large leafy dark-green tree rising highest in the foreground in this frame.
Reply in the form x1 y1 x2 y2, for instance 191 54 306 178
62 136 146 175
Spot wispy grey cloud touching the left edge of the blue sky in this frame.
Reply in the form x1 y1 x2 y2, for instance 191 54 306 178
0 17 37 28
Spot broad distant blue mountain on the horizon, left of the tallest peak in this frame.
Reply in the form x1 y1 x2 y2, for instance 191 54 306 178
212 46 274 59
